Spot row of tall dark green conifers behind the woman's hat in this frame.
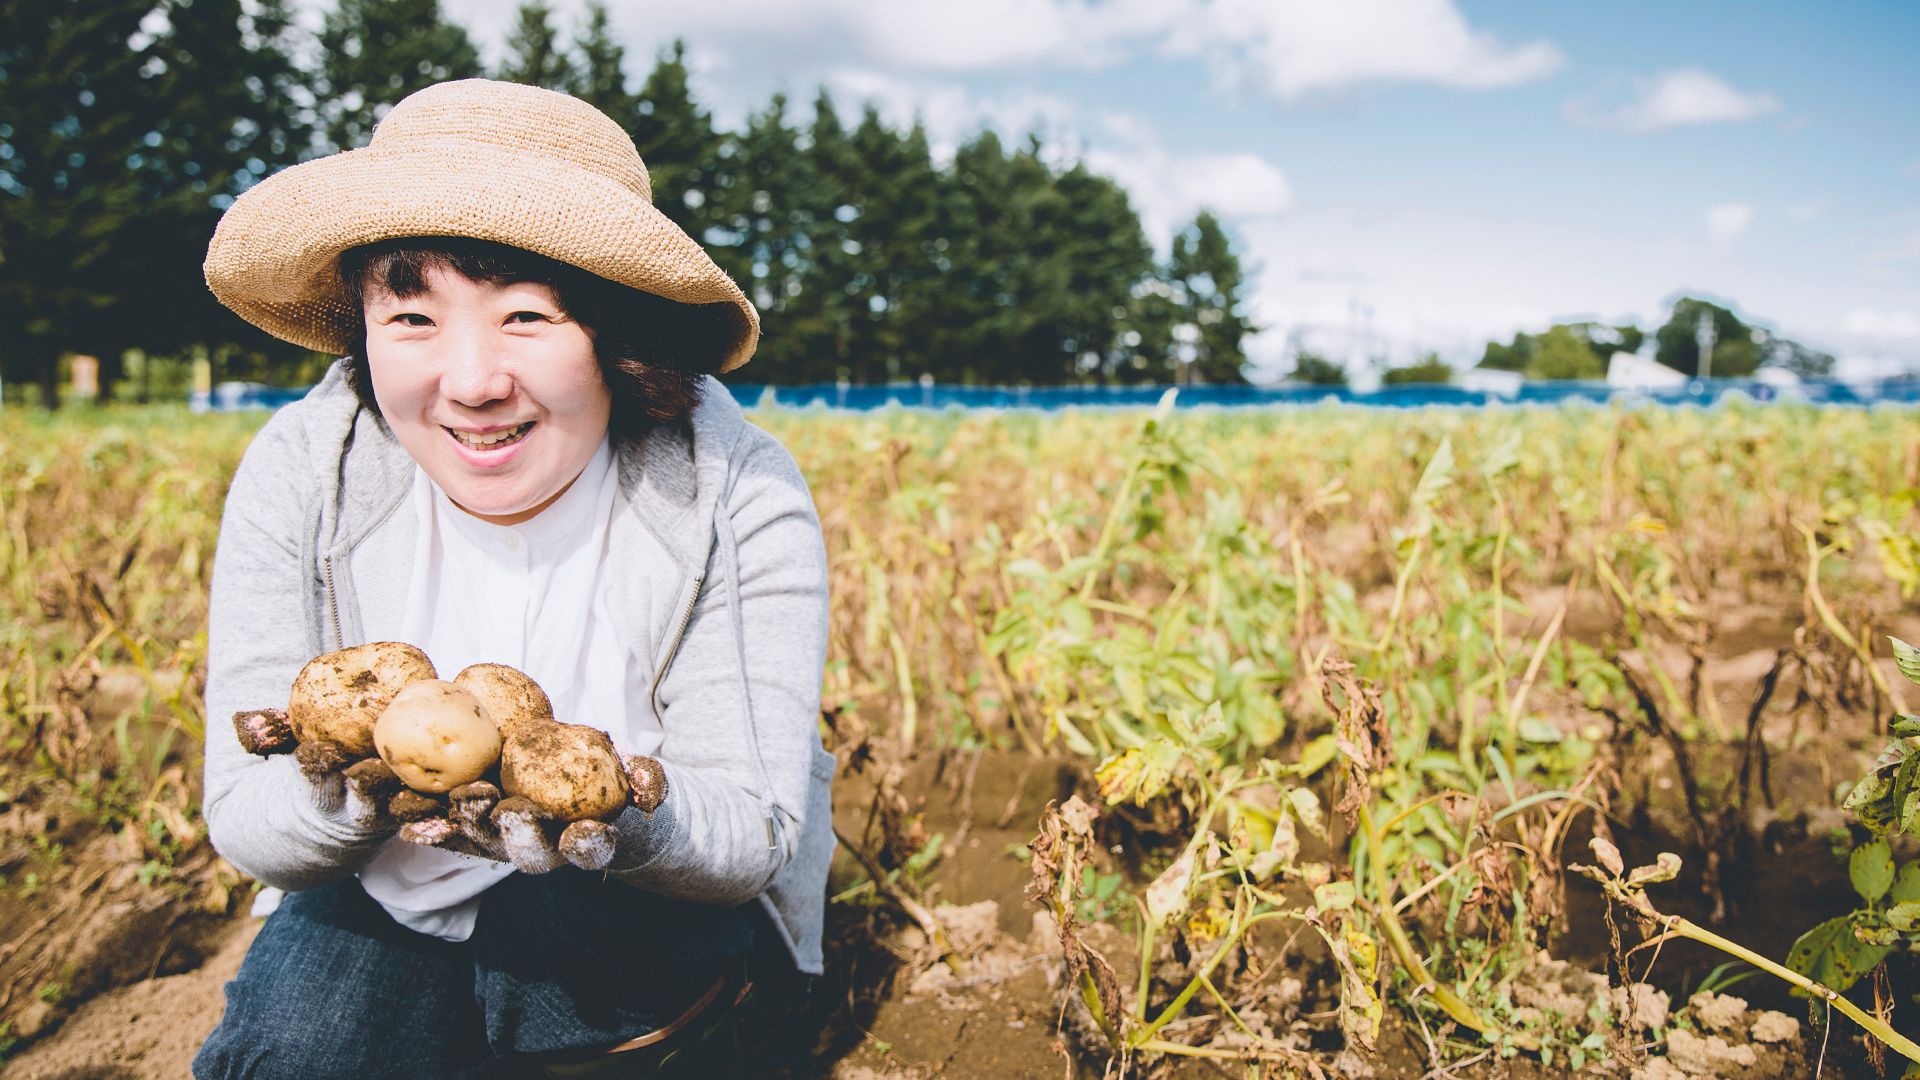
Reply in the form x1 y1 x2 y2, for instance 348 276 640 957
0 0 1254 405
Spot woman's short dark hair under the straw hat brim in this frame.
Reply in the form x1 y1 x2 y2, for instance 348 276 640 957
340 236 732 438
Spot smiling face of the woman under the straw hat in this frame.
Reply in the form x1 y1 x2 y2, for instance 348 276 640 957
365 267 612 525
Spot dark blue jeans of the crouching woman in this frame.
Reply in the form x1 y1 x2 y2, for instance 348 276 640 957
194 867 755 1080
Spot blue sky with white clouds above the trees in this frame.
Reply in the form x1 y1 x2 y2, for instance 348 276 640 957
334 0 1920 379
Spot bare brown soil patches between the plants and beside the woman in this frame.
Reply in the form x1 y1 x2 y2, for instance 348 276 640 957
0 595 1920 1080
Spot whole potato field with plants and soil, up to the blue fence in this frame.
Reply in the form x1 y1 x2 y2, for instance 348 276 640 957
0 405 1920 1080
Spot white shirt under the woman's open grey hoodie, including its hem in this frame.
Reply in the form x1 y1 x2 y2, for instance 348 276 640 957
359 440 660 942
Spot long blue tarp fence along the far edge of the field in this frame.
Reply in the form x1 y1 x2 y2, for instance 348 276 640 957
194 377 1920 411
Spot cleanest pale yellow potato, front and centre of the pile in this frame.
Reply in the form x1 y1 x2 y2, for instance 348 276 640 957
372 678 499 794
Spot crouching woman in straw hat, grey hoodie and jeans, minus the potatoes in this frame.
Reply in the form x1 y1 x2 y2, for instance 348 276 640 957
194 81 833 1078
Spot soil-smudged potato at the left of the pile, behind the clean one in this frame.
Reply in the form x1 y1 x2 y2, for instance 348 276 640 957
286 642 434 761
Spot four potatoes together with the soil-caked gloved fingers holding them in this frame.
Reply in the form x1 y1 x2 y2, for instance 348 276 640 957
234 642 664 872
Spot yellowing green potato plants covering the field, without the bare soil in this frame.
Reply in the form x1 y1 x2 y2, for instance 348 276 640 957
0 405 1920 1061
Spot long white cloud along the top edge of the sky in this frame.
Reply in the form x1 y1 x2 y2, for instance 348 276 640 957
432 0 1565 104
